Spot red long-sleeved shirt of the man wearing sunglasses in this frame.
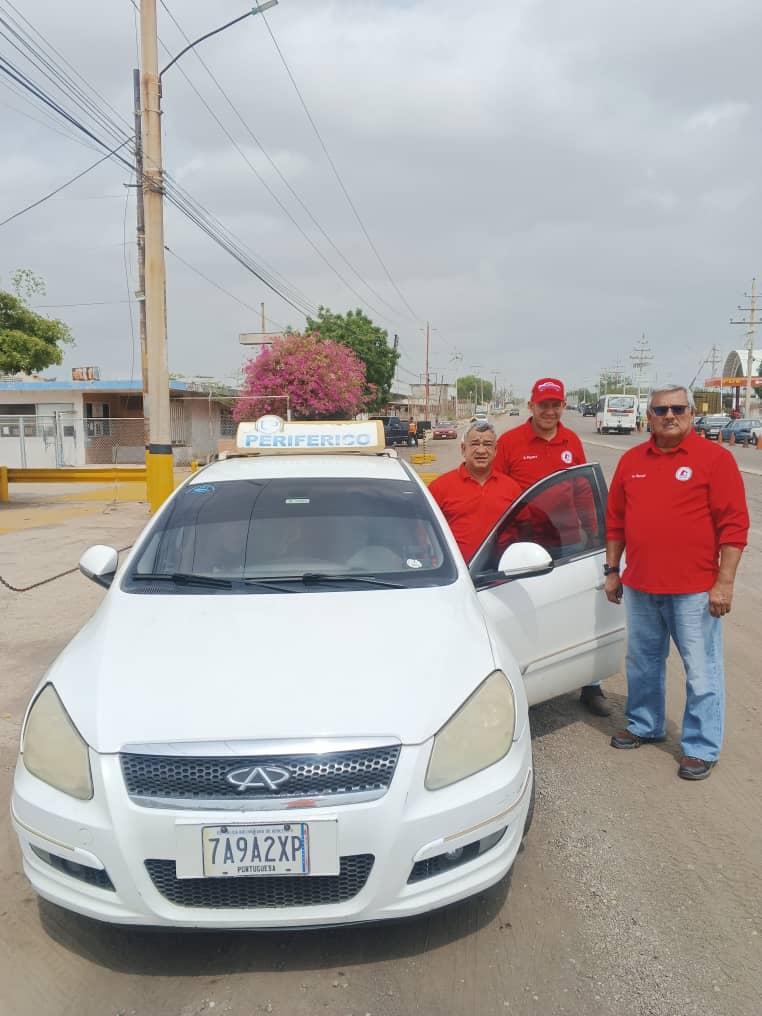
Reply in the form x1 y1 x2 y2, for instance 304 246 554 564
606 431 749 593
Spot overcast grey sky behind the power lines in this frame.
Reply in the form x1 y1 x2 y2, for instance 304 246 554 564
0 0 762 394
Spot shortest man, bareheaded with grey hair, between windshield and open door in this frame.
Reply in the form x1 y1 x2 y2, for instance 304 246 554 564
429 421 521 561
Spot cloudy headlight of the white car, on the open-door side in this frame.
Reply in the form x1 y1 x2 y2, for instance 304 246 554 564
425 671 516 790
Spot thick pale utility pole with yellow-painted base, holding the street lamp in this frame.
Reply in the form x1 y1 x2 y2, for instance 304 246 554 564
140 0 175 511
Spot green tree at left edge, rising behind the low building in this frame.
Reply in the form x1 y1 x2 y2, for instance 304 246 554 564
0 268 74 374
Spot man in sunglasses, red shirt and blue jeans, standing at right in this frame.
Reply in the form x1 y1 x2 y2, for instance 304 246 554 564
604 385 749 779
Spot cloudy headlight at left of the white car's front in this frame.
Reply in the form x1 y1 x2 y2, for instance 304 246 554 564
21 685 92 801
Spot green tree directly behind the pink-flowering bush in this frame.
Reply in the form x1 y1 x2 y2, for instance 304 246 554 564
307 307 399 412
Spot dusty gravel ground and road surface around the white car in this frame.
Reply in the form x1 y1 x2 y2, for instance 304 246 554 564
0 416 762 1016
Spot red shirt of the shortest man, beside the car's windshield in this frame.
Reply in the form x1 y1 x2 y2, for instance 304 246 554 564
429 462 521 561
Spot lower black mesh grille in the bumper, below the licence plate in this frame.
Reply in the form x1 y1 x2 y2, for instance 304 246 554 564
145 853 375 909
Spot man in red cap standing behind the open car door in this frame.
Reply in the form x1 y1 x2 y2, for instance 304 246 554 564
495 378 611 716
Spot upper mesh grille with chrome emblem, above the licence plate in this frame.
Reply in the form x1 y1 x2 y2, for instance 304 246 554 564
120 745 399 808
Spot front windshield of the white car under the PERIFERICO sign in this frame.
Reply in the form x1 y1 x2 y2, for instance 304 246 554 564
122 478 456 594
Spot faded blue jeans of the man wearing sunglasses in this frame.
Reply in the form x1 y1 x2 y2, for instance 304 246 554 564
624 586 724 762
